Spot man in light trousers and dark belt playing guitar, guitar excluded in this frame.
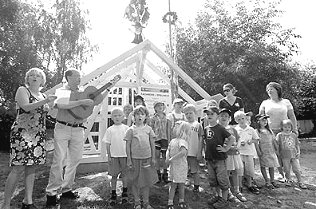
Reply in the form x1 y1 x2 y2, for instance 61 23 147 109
46 68 115 207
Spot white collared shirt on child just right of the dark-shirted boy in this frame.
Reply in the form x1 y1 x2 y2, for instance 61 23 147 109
235 125 259 157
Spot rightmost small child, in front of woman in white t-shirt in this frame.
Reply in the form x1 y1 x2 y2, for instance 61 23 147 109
276 119 307 189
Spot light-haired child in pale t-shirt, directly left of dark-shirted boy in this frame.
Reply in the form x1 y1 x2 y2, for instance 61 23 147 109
183 104 203 199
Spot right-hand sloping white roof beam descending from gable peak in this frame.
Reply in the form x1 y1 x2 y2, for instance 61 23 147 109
150 42 211 99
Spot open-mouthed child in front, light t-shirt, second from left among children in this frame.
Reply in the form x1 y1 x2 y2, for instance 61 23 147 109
125 105 158 209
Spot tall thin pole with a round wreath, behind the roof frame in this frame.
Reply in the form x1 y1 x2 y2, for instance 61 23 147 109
162 0 178 101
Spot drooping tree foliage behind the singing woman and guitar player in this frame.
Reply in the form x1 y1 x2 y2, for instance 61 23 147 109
0 0 97 105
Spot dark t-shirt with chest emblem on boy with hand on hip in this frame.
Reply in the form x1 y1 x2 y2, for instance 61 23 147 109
204 124 231 160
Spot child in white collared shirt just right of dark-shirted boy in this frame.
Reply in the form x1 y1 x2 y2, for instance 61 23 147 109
234 110 259 194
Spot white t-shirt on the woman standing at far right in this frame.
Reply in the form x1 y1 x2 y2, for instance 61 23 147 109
259 99 293 130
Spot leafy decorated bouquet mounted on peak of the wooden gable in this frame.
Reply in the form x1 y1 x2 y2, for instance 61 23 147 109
124 0 150 44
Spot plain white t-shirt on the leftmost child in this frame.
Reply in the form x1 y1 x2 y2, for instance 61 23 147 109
103 124 128 157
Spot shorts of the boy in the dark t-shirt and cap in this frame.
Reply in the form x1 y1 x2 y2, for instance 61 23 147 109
207 160 230 190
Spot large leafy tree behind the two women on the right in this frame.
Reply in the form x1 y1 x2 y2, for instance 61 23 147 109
176 0 300 113
